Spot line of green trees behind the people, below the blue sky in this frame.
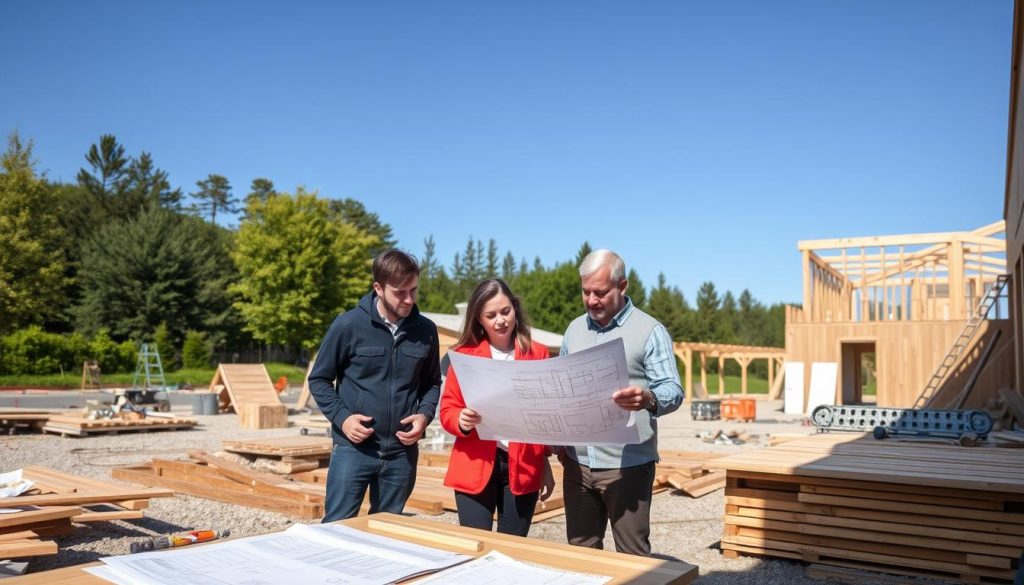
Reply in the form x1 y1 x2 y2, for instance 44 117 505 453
0 132 783 374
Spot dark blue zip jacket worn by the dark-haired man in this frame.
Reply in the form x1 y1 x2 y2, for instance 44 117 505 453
309 291 441 455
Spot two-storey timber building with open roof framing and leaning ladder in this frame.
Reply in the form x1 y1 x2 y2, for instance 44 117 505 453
785 220 1014 408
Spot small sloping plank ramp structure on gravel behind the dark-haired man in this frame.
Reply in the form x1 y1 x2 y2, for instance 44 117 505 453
210 364 288 428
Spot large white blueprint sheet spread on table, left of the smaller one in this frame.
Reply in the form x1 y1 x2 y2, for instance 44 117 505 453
86 525 470 585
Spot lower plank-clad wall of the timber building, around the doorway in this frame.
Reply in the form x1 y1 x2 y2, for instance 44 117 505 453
785 320 1015 408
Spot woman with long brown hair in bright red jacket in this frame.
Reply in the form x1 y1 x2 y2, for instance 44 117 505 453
440 279 555 536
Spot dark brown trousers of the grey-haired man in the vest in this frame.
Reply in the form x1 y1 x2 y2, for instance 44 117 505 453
562 458 654 556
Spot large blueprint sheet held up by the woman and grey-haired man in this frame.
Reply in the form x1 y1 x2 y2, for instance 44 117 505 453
449 339 640 445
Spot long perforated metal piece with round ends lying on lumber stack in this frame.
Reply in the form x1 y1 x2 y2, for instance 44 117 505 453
811 405 992 446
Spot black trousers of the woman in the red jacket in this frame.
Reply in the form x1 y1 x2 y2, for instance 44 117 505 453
455 449 540 536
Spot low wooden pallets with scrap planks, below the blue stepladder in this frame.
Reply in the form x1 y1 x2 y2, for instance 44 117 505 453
0 408 197 436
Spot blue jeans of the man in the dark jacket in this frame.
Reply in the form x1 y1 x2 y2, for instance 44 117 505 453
324 444 420 523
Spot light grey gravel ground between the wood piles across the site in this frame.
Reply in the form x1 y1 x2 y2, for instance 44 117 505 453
0 396 820 585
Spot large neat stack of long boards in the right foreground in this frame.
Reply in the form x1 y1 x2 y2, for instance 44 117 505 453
715 434 1024 583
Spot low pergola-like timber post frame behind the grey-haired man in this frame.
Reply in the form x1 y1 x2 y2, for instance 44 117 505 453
673 341 785 401
